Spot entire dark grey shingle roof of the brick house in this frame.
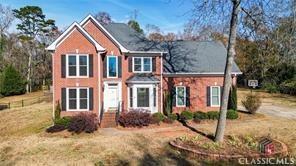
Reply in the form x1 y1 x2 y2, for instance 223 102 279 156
104 23 240 73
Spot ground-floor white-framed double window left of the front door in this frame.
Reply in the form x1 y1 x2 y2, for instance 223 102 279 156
66 88 89 111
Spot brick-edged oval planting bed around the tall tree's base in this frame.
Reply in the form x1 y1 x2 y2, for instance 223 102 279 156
170 135 288 159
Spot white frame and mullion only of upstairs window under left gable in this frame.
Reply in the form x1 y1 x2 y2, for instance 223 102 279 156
66 54 89 78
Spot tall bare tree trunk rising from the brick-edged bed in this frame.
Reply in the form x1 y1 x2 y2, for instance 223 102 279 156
215 0 240 142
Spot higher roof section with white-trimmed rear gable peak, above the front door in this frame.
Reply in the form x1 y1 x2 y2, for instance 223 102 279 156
80 15 162 53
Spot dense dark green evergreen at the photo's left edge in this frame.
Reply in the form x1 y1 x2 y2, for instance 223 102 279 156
0 65 25 96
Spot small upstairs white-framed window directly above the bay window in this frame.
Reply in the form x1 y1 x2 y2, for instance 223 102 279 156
133 57 152 73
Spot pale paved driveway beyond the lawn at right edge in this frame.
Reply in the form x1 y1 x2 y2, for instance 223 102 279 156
238 103 296 119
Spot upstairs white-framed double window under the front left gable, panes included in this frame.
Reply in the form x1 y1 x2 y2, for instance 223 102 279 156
66 54 89 78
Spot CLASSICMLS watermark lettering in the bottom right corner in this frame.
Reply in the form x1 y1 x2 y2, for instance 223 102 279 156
238 157 296 165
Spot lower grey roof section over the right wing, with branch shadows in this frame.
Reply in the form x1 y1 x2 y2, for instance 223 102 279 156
160 41 241 75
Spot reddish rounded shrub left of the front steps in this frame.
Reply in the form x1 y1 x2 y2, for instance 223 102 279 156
68 113 98 133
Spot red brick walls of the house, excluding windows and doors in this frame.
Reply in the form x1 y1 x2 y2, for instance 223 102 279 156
49 14 237 115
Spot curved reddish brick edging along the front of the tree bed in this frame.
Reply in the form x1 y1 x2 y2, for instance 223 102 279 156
169 139 288 159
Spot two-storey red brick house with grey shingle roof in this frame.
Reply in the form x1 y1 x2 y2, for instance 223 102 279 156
47 15 241 126
